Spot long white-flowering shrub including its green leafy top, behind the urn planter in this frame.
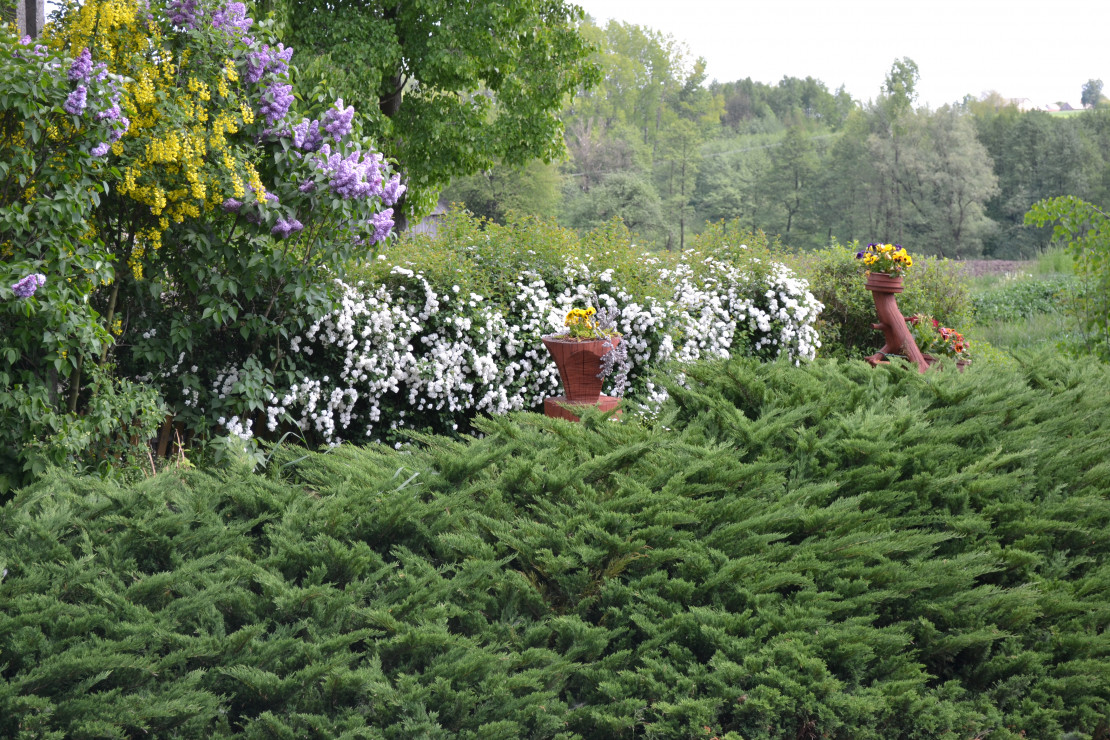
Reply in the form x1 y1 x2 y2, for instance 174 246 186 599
134 217 820 444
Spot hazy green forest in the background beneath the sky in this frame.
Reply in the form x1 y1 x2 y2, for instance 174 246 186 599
444 21 1110 259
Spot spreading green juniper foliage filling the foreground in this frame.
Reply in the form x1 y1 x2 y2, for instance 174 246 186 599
0 357 1110 740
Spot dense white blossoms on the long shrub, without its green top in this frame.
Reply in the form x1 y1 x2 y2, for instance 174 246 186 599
231 248 821 444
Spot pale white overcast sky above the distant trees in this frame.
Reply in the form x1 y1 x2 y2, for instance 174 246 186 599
572 0 1110 108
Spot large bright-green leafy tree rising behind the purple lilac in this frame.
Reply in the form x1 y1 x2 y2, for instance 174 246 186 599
263 0 597 226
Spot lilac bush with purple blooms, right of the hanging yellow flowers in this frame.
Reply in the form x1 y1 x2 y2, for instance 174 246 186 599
108 0 405 448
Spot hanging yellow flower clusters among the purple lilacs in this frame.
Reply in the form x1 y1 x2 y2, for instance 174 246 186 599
46 0 273 278
